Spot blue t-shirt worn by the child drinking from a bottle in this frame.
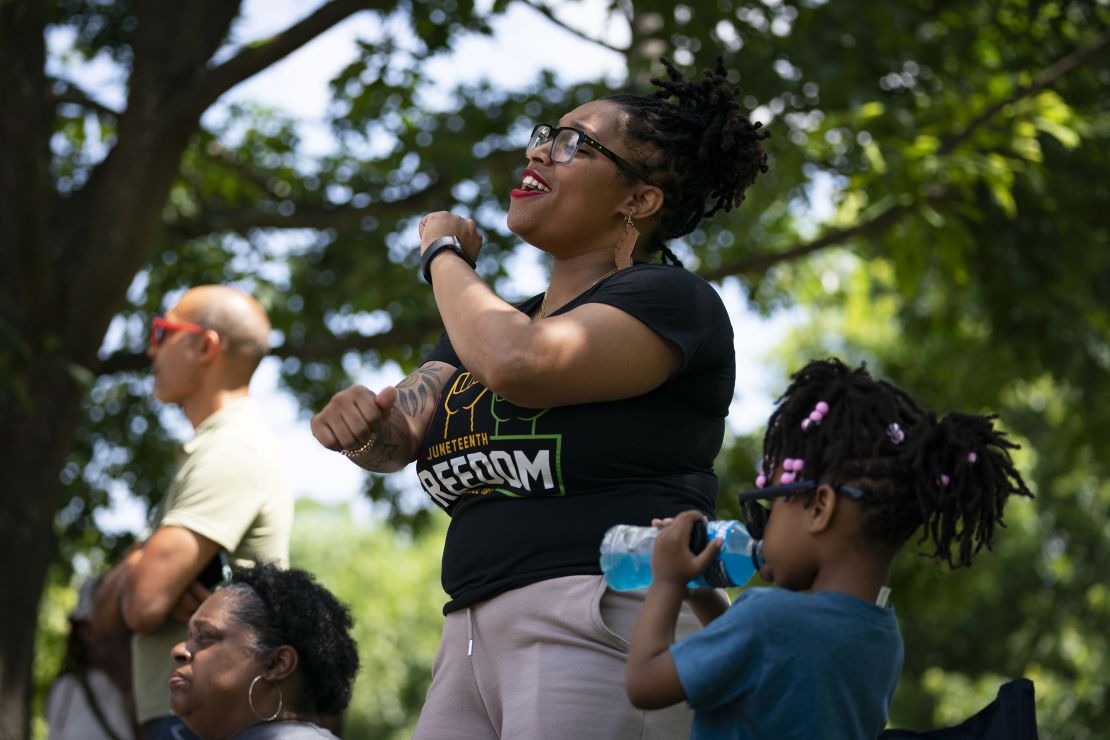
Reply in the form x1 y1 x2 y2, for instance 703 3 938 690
670 588 904 740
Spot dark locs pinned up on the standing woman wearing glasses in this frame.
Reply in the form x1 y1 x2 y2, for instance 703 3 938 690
605 57 769 265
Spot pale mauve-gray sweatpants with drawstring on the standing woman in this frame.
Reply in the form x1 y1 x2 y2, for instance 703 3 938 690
413 576 698 740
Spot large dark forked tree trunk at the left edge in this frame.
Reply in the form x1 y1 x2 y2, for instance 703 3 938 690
0 0 374 740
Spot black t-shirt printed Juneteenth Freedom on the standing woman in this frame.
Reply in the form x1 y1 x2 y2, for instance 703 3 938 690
416 265 736 614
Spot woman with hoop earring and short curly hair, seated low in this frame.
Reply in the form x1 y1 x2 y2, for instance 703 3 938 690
170 564 359 740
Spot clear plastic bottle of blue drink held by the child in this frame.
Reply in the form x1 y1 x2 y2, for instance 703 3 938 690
602 519 758 591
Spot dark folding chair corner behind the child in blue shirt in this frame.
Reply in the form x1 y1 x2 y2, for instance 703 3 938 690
879 678 1037 740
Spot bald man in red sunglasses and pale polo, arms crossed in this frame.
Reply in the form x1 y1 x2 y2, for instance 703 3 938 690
92 285 293 740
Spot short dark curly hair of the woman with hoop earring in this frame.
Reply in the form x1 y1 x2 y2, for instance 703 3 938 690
222 562 359 714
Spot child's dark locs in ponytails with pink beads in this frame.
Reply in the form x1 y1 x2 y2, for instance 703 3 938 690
761 358 1032 568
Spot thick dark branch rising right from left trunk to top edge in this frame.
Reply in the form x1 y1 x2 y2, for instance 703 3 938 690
194 0 384 108
